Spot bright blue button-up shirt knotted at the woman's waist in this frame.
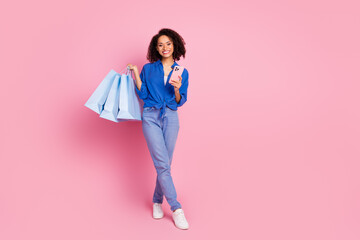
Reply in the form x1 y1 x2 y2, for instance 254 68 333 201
135 59 189 116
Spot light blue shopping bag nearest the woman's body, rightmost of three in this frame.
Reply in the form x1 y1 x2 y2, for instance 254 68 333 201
117 69 141 121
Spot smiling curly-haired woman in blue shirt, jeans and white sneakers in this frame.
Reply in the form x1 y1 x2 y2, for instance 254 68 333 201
128 28 189 229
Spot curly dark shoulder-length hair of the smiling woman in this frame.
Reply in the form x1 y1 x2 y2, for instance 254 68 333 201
146 28 186 63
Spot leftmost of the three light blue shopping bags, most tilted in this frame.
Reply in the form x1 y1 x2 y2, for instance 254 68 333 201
85 70 118 114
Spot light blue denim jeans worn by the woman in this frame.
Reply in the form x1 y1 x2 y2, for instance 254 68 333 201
142 107 181 211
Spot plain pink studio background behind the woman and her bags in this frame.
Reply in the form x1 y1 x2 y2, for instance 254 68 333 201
0 0 360 240
